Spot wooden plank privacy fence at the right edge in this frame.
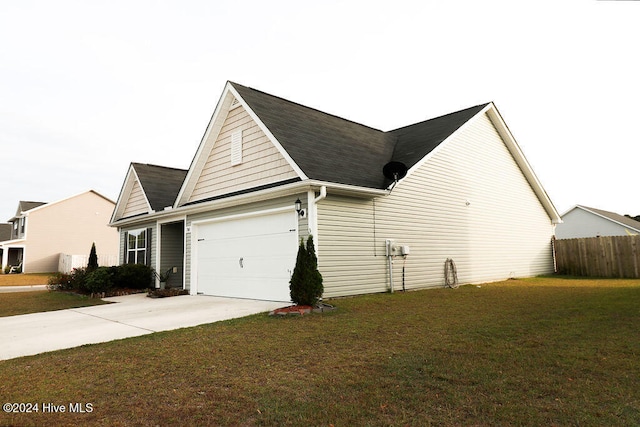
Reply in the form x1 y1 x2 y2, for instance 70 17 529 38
555 236 640 279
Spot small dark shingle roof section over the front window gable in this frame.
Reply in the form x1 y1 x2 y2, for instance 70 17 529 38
131 163 187 211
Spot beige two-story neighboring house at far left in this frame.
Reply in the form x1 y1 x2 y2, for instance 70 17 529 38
0 190 119 273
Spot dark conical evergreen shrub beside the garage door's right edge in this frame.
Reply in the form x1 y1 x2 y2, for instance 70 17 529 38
289 236 324 306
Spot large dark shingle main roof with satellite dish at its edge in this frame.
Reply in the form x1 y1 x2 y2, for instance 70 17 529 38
231 83 487 188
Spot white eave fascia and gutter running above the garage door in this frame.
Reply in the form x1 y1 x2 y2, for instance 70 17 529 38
109 180 389 227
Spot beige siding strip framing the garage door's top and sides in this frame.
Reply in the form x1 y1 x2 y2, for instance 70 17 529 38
185 193 309 289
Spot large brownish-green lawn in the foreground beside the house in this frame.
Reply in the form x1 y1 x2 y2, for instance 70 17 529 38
0 278 640 426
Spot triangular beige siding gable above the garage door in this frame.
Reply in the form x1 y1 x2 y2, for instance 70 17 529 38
189 107 297 202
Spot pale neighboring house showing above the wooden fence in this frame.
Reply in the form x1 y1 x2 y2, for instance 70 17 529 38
556 205 640 239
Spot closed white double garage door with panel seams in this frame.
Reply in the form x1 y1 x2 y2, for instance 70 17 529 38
197 211 298 301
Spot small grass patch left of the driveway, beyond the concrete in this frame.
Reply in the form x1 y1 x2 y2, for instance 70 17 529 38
0 291 106 317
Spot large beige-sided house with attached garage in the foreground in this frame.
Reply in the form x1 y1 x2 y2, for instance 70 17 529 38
112 82 560 301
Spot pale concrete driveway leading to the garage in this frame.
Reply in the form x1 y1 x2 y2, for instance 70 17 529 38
0 294 288 360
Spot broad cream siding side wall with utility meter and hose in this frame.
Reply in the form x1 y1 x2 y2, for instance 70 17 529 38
318 116 553 297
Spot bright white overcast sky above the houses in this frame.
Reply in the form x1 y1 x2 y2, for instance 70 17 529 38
0 0 640 221
